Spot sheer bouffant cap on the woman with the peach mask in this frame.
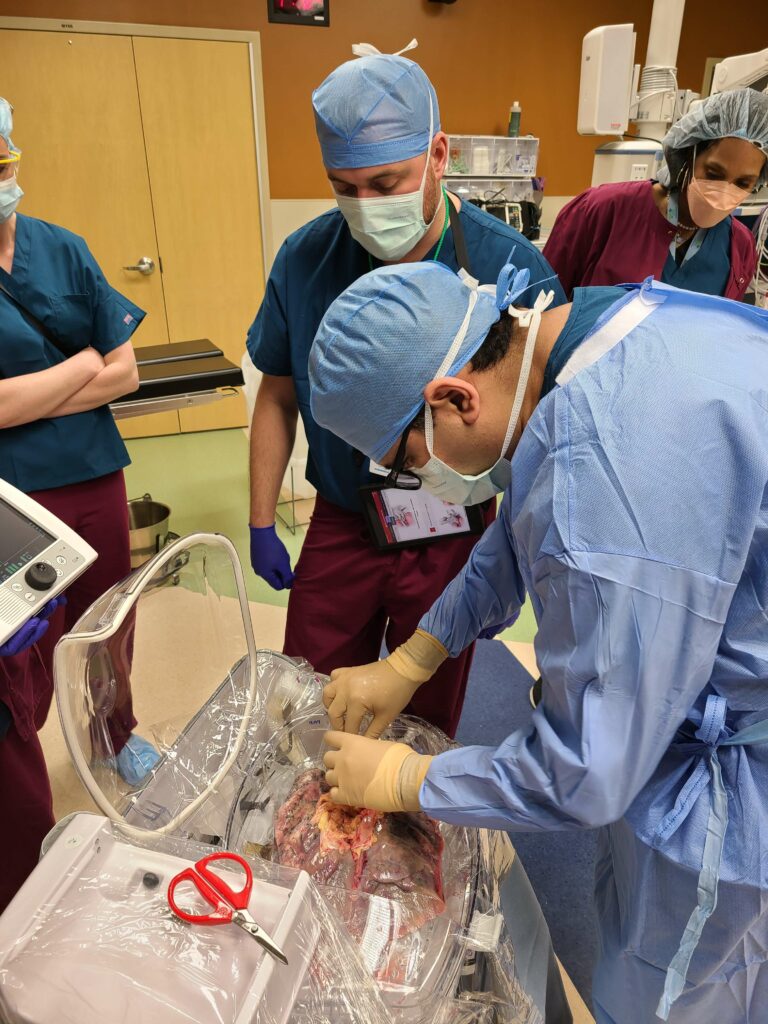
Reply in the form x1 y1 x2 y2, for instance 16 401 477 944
658 89 768 187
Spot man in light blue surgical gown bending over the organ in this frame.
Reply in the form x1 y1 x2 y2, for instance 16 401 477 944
309 264 768 1024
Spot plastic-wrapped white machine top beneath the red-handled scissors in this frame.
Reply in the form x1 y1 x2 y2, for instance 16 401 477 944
0 814 391 1024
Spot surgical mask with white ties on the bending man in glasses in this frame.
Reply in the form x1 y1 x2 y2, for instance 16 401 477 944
411 282 555 505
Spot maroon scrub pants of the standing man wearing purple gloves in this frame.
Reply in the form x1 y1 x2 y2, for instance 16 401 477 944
284 495 496 737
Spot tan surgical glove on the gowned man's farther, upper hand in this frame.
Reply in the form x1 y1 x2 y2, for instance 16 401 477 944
323 630 449 738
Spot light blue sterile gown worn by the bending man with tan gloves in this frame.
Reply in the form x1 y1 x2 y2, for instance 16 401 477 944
420 283 768 1024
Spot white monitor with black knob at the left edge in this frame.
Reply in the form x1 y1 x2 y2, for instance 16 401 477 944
0 479 97 643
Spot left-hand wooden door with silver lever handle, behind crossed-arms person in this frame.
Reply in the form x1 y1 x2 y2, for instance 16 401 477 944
0 29 179 437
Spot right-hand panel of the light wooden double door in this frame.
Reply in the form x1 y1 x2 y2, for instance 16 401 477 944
133 36 264 431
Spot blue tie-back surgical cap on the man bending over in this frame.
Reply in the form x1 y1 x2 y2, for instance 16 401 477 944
309 256 530 461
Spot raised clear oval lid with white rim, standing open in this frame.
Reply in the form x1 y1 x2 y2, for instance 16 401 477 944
54 535 263 834
